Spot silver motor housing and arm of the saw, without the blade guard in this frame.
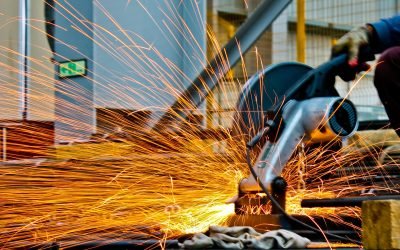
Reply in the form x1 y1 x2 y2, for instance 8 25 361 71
240 97 358 193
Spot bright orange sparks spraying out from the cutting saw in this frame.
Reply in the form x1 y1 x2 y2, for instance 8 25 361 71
0 0 399 249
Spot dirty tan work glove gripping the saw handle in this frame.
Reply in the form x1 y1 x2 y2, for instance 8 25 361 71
332 26 372 67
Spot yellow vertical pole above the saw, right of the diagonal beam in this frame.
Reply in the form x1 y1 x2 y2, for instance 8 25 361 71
296 0 306 63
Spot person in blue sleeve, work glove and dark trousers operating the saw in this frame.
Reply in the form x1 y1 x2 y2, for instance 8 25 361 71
332 15 400 137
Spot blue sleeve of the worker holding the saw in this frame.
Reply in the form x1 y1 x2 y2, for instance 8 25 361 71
370 15 400 53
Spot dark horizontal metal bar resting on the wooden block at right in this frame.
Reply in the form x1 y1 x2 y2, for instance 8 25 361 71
301 195 400 207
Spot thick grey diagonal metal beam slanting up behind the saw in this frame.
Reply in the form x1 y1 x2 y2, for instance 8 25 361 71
150 0 292 131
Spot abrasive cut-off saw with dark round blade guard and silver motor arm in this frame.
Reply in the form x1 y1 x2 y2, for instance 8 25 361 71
233 52 373 211
